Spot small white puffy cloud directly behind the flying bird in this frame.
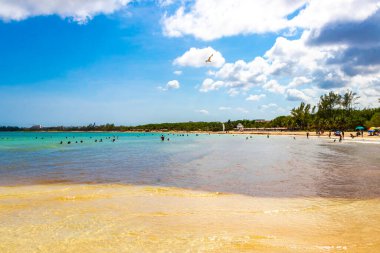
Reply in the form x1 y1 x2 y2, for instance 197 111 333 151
173 47 225 68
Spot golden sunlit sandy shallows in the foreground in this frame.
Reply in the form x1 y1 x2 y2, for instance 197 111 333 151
0 185 380 252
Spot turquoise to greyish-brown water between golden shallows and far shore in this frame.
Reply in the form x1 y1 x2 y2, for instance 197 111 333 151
0 132 380 198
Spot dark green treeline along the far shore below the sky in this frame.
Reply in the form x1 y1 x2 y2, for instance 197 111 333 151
0 91 380 132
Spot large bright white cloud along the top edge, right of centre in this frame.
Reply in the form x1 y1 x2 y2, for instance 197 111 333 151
163 0 379 40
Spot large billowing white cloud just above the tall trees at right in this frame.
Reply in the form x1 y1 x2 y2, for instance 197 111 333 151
193 31 380 106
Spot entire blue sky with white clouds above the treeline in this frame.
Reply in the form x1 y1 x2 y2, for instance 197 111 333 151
0 0 380 127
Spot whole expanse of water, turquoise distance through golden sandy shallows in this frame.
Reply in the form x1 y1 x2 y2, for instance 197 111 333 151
0 133 380 252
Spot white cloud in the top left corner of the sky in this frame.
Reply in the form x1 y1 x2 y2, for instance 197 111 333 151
0 0 131 23
